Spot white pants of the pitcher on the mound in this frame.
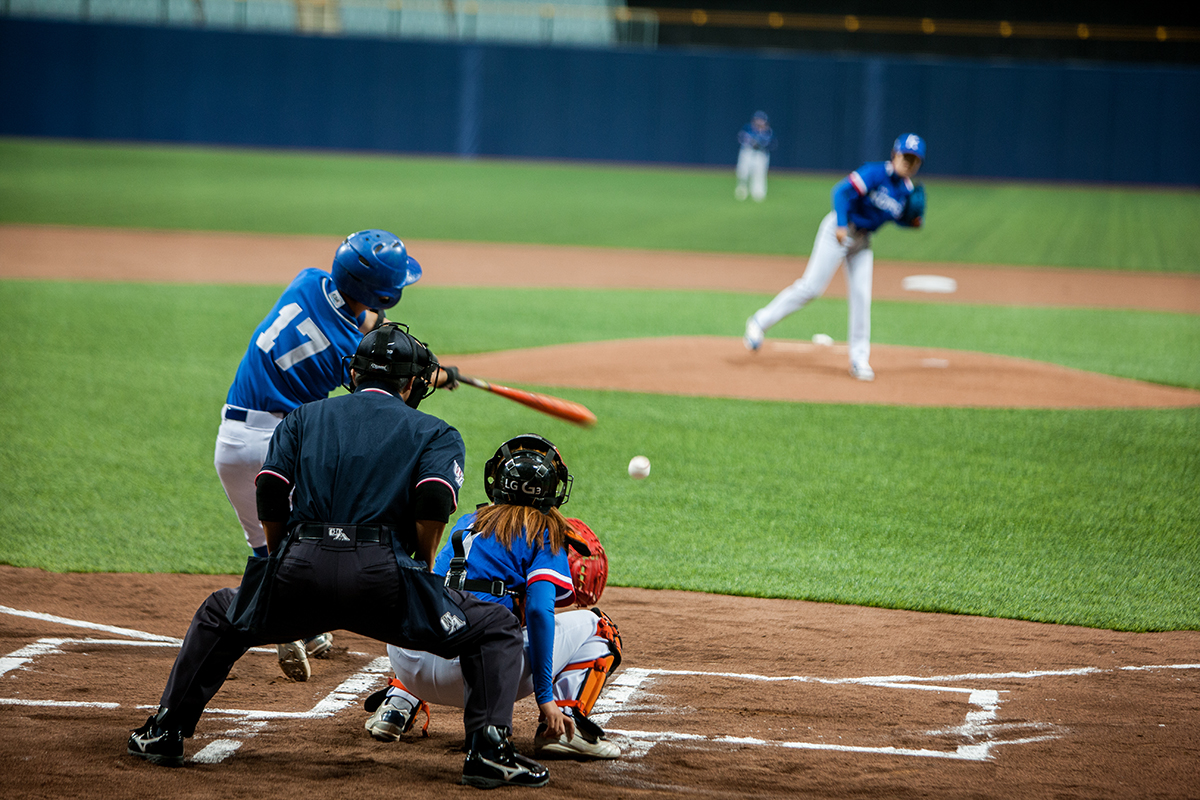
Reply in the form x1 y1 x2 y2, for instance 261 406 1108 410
754 211 875 367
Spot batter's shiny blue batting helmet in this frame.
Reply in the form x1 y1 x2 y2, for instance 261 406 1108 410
332 230 421 309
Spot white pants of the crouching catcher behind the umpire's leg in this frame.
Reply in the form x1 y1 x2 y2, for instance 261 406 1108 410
388 610 611 709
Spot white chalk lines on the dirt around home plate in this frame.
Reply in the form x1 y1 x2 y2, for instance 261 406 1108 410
0 606 1200 763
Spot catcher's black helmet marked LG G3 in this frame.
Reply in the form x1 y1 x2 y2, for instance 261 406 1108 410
484 433 574 511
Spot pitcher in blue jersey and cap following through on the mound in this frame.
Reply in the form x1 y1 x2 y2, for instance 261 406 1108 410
743 133 925 380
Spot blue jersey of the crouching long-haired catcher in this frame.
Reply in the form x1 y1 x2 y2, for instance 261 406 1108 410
433 513 575 609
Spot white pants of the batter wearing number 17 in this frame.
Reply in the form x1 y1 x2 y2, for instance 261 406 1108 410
212 405 283 548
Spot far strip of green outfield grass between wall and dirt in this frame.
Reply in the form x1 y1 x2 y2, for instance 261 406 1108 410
0 139 1200 272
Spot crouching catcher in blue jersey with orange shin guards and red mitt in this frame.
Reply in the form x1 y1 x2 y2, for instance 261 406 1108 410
365 434 622 758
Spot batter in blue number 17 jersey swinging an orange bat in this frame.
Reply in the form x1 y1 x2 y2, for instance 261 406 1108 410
214 230 421 681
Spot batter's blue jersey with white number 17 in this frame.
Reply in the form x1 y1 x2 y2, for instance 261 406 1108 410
226 269 362 414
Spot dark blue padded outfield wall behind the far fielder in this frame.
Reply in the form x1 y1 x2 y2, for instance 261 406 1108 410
0 18 1200 185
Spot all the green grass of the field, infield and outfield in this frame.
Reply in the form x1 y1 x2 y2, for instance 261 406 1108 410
0 139 1200 630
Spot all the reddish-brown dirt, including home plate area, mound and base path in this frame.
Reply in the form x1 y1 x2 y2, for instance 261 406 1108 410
0 225 1200 800
